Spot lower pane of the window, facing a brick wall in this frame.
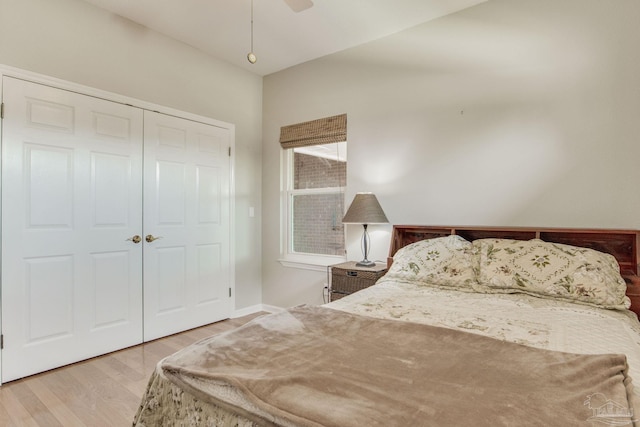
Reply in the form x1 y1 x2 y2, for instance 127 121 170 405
292 193 345 255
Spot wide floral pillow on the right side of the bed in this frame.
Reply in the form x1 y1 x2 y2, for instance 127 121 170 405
473 239 631 308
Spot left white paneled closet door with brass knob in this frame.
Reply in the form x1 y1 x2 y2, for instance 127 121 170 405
2 77 143 381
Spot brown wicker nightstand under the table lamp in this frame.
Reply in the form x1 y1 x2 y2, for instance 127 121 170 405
327 261 387 302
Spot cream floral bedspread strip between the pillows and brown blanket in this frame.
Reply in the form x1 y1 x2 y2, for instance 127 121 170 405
328 278 640 396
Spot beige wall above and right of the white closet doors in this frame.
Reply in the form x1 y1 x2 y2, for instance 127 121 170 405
0 0 262 309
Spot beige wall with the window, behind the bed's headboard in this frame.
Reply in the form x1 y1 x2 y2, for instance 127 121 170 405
262 0 640 307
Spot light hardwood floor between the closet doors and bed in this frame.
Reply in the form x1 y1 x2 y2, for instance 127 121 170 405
0 313 261 427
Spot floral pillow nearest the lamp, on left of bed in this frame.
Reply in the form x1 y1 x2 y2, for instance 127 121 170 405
385 235 476 291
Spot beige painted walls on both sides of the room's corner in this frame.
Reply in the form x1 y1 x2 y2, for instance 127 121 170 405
0 0 640 308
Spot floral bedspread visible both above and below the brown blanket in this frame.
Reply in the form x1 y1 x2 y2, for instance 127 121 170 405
134 279 640 427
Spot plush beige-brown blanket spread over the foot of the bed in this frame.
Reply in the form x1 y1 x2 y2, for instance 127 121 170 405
162 307 633 427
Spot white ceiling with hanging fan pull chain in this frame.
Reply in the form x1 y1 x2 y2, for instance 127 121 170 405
84 0 486 76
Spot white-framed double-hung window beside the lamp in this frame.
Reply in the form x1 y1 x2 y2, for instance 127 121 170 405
280 116 347 269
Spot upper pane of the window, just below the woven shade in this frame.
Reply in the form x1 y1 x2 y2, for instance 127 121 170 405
293 142 347 190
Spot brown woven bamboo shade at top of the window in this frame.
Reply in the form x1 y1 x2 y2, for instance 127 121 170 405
280 114 347 148
